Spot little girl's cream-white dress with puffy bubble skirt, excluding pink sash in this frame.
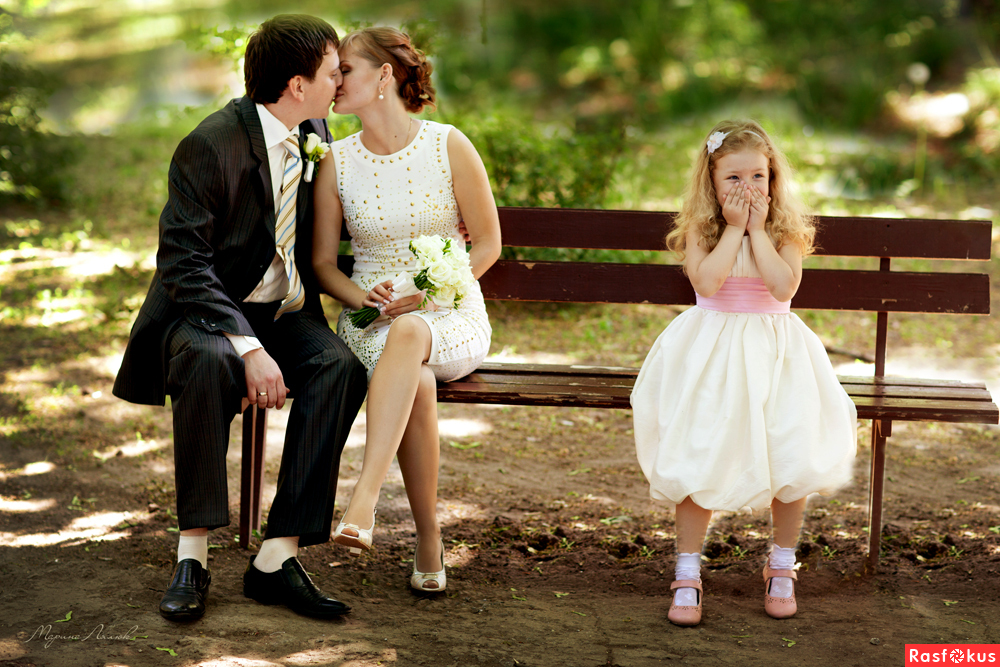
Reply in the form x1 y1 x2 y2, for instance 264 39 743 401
631 237 857 511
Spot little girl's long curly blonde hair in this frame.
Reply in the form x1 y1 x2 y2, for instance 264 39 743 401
667 120 816 261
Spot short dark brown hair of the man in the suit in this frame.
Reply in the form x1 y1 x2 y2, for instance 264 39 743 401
243 14 340 104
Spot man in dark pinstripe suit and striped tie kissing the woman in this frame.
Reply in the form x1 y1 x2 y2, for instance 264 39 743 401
114 15 366 620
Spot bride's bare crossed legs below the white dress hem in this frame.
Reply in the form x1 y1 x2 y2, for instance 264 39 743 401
341 315 443 572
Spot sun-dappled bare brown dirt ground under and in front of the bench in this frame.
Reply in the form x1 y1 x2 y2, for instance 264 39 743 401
0 366 1000 667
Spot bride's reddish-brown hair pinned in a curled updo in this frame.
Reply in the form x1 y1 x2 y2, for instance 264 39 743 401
340 28 437 113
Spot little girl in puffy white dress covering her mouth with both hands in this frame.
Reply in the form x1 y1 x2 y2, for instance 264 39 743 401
632 121 857 625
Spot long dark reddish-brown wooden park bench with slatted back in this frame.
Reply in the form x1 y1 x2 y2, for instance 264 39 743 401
240 208 1000 568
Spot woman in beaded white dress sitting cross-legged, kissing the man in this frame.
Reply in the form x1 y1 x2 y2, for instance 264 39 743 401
313 28 501 591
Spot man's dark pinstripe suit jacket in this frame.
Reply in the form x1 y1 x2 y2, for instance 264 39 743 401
113 97 331 405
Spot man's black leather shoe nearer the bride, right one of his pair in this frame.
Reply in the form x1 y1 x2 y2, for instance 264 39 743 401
243 556 351 618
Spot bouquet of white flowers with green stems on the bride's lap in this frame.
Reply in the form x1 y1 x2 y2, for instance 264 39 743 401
348 235 476 329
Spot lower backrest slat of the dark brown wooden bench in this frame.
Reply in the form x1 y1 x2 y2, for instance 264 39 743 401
480 260 990 314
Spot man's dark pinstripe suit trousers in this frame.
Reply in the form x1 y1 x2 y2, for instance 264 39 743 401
164 303 367 546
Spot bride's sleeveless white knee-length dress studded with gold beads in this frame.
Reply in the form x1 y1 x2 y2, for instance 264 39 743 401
331 120 493 381
